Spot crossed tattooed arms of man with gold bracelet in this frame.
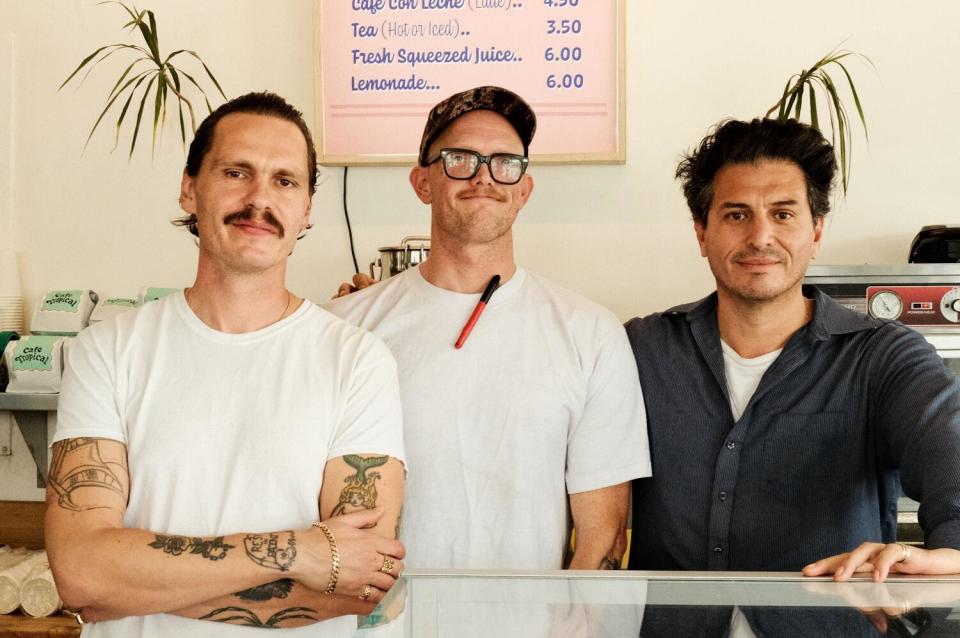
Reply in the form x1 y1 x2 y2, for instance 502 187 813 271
45 438 404 627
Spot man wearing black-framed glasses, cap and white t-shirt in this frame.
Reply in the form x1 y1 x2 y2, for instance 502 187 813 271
329 86 650 570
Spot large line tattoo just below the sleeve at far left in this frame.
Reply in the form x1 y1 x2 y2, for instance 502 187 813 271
49 438 127 512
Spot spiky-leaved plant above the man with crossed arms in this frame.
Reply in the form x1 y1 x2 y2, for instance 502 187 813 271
59 0 226 157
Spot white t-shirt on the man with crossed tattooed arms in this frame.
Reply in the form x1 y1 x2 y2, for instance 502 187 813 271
54 292 403 638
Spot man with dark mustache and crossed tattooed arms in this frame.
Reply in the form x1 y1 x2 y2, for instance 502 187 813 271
46 93 404 637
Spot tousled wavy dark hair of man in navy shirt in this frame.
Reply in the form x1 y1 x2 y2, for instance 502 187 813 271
676 119 837 226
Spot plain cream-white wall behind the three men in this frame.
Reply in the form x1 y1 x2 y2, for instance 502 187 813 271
0 0 960 500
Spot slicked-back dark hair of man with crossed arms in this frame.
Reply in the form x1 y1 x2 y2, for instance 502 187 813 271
172 91 317 239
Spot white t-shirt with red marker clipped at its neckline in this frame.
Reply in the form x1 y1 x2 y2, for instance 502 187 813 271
328 268 651 570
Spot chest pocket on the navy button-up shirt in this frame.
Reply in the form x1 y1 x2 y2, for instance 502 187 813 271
762 412 862 508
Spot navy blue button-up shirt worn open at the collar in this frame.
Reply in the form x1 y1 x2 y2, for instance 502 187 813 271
626 286 960 571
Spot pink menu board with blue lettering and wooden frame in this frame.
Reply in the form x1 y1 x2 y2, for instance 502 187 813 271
314 0 626 165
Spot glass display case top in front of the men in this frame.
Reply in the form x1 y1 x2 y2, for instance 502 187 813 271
355 571 960 638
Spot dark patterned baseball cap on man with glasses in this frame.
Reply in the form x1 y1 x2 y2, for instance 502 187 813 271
419 86 537 166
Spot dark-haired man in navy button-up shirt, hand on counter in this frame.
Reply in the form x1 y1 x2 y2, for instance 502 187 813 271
627 120 960 635
